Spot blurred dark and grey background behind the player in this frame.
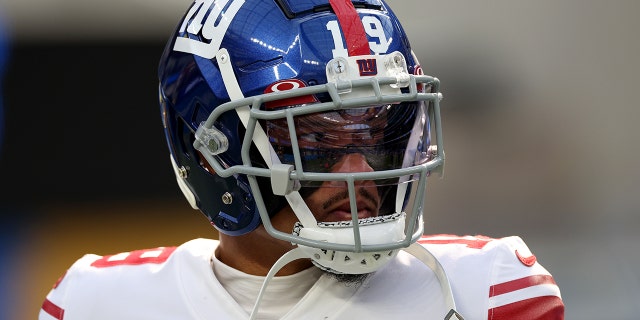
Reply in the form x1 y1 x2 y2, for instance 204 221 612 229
0 0 640 319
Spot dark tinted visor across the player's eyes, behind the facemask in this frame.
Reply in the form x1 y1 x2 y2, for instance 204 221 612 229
264 102 429 186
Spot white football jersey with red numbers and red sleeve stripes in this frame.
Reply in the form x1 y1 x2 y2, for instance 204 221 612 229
39 235 564 320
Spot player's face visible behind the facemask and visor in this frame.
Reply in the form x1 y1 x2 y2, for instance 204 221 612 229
266 106 388 231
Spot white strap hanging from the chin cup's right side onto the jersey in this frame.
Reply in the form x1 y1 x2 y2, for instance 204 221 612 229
403 243 464 320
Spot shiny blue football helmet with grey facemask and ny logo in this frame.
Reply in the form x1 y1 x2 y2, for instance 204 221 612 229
159 0 444 273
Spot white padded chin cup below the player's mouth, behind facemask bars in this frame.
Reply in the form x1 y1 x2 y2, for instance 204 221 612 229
296 213 405 274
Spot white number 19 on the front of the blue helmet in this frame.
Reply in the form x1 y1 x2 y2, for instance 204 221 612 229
327 16 391 58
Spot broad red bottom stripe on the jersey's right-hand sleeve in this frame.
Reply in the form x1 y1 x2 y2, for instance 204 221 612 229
487 296 564 320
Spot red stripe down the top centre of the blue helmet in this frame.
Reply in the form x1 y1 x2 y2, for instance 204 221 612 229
329 0 370 56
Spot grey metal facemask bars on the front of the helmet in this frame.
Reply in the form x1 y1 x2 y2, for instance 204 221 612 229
194 53 444 252
